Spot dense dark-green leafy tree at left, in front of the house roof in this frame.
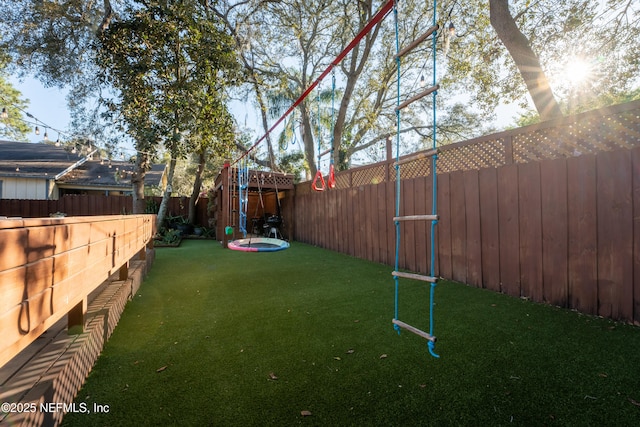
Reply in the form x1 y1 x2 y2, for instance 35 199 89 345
97 0 238 219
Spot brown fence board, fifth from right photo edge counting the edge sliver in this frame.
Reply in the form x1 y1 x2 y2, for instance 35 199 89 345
518 163 543 302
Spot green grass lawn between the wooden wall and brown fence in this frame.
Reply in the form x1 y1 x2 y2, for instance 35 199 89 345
64 241 640 426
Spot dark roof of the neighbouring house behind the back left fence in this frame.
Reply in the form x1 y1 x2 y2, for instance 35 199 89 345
0 141 166 188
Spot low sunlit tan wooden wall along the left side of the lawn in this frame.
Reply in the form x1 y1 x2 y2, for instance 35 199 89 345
0 215 155 367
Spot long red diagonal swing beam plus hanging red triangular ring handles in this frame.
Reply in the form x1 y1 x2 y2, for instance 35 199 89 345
231 0 395 171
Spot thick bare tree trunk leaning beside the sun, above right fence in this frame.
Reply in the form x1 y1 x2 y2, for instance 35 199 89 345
489 0 562 120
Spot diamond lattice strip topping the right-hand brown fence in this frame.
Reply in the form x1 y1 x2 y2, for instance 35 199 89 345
296 101 640 194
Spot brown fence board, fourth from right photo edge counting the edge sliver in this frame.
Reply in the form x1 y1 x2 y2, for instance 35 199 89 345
540 159 568 306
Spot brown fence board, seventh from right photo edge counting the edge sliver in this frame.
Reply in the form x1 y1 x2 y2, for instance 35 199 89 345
478 168 500 292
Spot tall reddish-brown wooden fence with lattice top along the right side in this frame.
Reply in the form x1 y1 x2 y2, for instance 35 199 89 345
294 102 640 323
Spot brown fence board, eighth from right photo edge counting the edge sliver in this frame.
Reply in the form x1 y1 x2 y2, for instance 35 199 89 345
464 170 482 288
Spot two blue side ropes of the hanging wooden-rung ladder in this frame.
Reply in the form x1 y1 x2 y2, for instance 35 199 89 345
393 0 440 357
